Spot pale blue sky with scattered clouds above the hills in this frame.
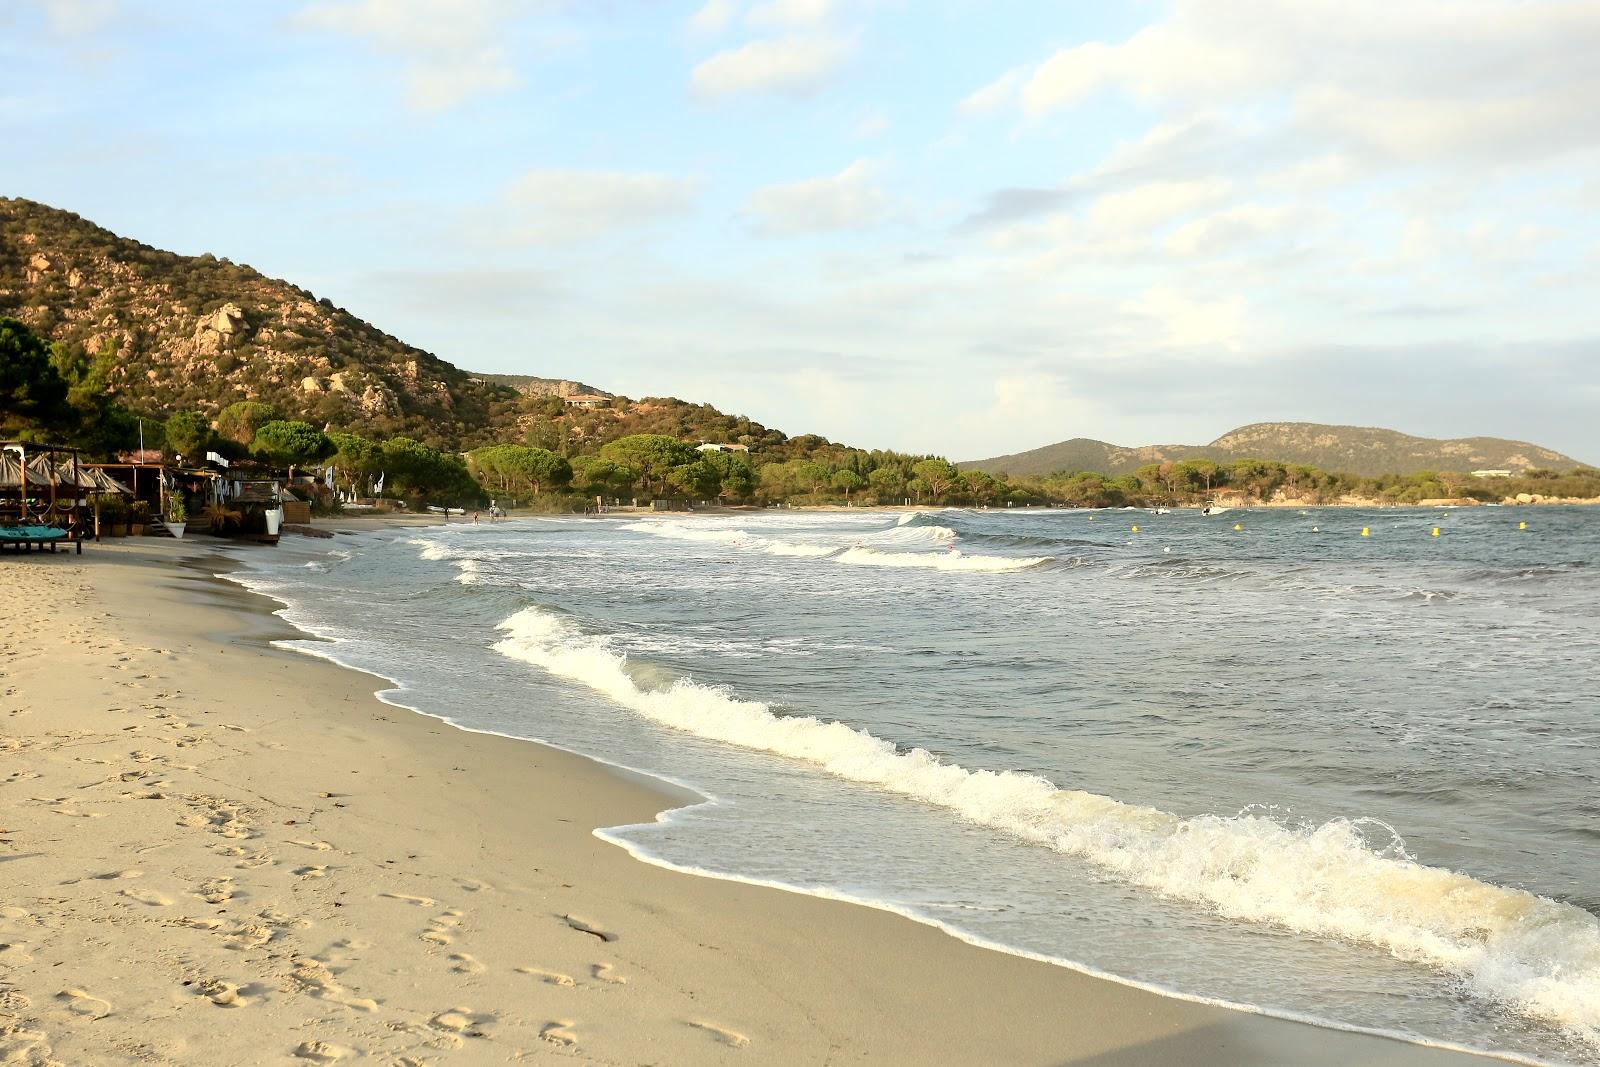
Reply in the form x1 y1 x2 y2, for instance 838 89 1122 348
0 0 1600 462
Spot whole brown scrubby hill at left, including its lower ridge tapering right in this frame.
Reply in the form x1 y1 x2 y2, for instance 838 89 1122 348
0 197 883 461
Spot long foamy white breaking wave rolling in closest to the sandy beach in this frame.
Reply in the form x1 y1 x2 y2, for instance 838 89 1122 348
494 608 1600 1045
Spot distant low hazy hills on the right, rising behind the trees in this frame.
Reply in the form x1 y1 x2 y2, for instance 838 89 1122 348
957 422 1584 477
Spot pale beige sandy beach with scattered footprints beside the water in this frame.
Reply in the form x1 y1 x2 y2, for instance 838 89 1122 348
0 539 1483 1067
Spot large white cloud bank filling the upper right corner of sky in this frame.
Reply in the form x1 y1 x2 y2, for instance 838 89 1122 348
968 0 1600 160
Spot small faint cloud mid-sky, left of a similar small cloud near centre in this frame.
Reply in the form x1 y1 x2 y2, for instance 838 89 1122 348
501 170 696 243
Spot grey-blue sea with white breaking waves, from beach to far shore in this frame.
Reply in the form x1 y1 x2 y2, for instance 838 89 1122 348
234 507 1600 1064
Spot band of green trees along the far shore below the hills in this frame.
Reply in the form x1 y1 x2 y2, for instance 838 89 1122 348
0 318 1600 512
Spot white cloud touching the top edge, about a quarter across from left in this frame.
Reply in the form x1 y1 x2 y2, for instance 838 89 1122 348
291 0 547 112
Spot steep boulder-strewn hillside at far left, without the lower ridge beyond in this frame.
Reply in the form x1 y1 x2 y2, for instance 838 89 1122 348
0 198 520 446
